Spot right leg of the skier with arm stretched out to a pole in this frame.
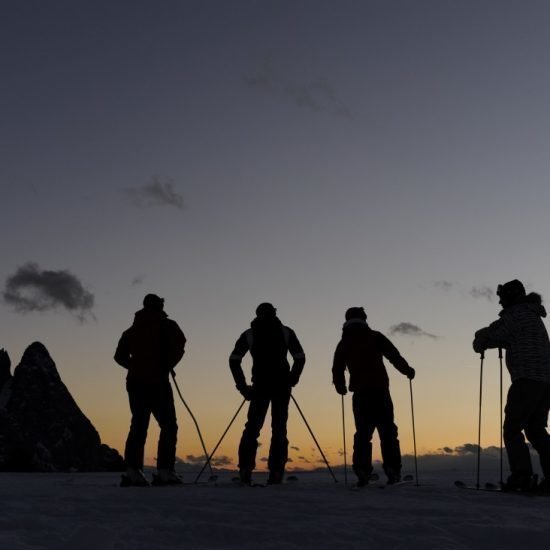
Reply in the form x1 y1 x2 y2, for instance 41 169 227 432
376 389 401 483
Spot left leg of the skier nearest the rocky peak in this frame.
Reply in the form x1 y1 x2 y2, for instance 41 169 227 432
124 380 151 470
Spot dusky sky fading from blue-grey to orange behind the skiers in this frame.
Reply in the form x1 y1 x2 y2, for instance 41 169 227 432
0 0 550 467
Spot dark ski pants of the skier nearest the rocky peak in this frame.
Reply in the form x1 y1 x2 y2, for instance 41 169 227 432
124 379 178 470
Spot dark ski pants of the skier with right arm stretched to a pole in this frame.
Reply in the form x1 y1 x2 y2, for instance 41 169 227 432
353 388 401 475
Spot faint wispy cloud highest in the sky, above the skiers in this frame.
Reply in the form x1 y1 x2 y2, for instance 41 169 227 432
244 59 351 118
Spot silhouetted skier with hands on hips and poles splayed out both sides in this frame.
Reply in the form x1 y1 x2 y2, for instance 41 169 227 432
229 303 306 484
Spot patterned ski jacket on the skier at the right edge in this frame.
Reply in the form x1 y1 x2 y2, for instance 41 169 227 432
473 303 550 383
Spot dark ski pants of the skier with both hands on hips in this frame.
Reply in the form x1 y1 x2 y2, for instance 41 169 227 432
239 388 290 473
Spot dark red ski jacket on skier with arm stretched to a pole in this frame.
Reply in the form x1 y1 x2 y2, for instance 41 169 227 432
332 319 411 391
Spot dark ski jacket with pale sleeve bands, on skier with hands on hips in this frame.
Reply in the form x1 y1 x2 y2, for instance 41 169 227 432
229 317 306 390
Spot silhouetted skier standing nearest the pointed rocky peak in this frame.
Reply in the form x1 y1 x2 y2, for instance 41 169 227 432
115 294 186 485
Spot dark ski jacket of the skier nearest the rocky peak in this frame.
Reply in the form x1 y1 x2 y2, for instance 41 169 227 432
115 309 186 382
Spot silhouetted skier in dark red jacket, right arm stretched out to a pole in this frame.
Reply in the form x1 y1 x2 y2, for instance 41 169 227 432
332 307 415 486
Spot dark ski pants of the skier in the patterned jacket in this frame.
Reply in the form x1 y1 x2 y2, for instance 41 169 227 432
503 378 550 479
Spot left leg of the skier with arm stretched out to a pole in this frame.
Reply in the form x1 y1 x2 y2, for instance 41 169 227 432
352 391 375 484
